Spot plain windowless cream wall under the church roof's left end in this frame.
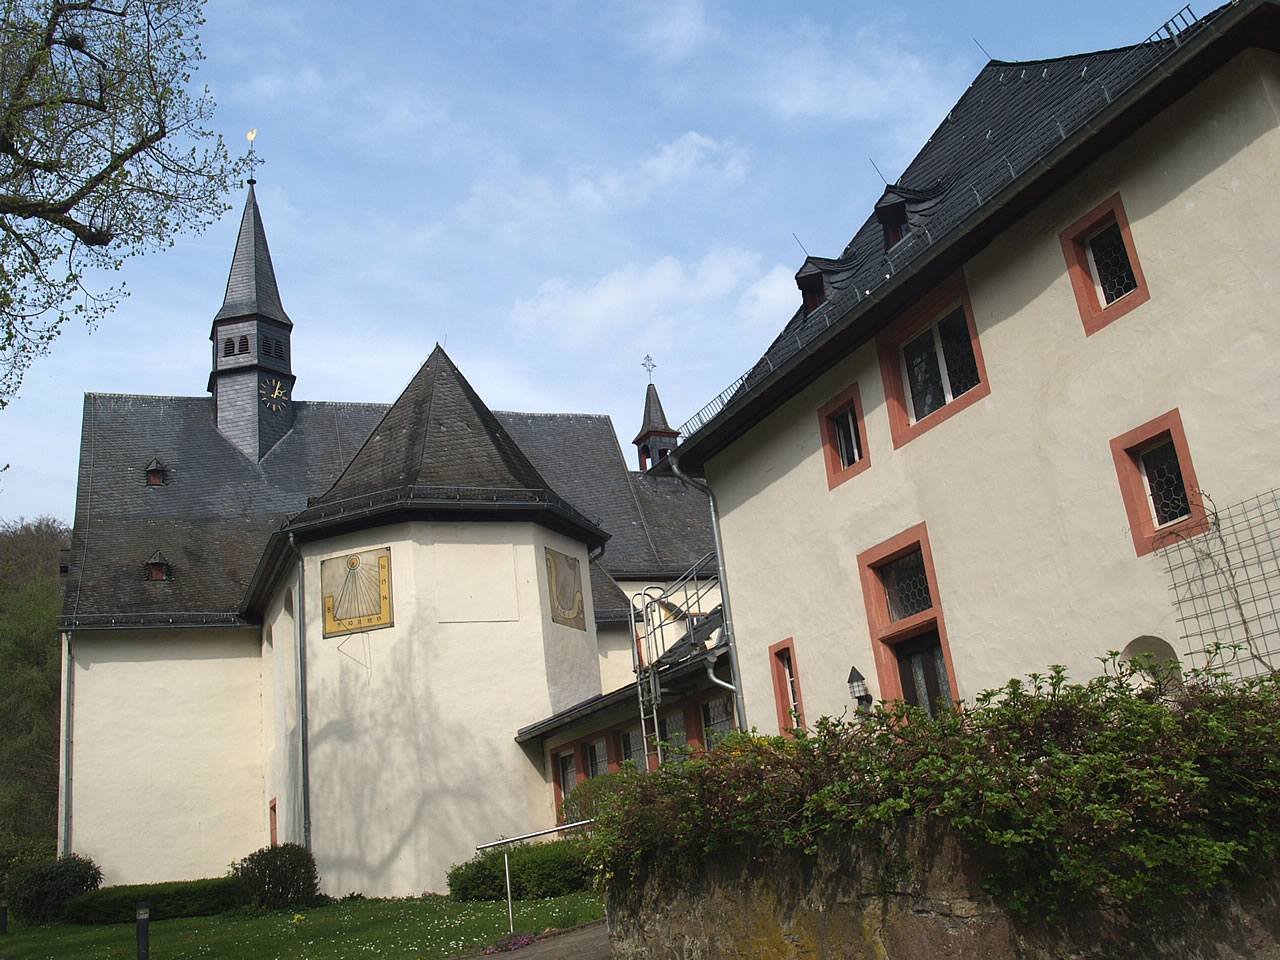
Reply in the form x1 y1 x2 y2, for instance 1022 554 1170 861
63 630 262 884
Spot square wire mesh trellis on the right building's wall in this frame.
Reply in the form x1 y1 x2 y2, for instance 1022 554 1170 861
1161 489 1280 680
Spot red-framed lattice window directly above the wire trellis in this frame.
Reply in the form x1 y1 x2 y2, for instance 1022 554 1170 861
1111 407 1208 557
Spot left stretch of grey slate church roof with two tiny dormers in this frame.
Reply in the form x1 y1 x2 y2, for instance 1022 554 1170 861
63 393 387 627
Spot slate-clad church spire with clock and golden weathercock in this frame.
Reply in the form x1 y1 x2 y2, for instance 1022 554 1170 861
209 180 294 462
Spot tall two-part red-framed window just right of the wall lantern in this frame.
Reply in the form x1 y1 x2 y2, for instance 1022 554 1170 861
858 524 960 713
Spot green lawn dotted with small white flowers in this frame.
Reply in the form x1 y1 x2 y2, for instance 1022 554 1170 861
0 893 604 960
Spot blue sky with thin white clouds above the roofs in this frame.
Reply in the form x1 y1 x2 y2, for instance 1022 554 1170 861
0 0 1210 521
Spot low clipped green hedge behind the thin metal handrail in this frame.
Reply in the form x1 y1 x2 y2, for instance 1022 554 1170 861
449 838 590 900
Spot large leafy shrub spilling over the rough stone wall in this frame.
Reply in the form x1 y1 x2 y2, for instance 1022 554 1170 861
591 654 1280 916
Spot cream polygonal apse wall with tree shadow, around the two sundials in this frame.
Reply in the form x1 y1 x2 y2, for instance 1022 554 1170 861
296 521 600 896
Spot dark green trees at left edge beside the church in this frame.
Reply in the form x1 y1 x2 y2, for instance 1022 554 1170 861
0 517 68 840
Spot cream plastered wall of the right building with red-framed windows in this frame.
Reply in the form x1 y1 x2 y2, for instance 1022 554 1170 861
707 51 1280 730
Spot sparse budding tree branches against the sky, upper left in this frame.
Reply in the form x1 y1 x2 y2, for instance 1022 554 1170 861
0 0 243 407
